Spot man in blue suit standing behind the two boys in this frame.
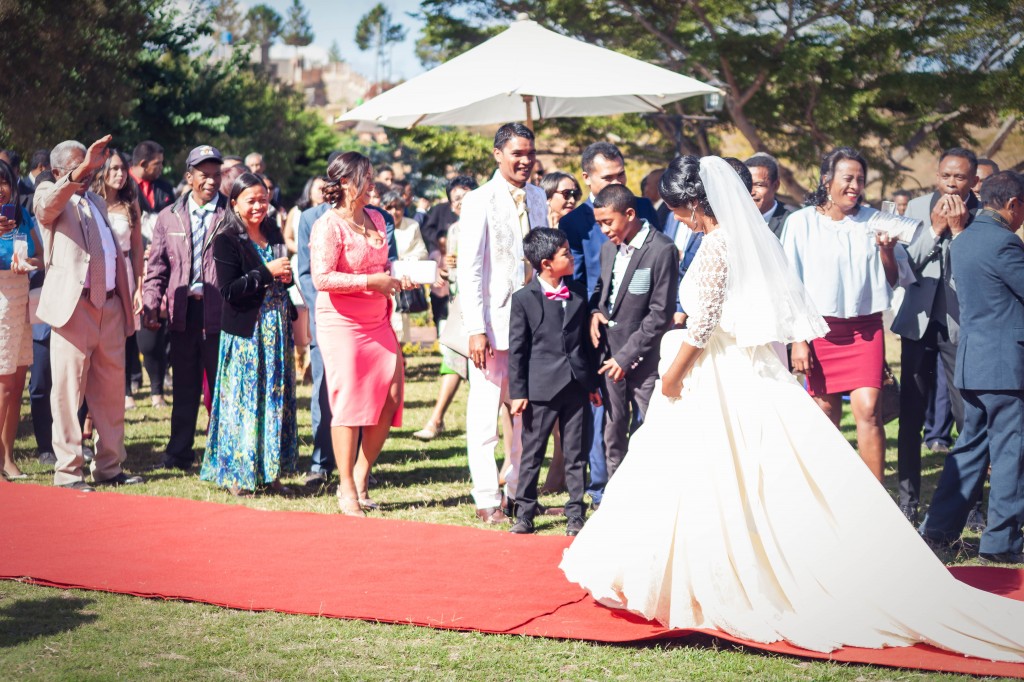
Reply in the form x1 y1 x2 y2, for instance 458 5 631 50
558 142 657 509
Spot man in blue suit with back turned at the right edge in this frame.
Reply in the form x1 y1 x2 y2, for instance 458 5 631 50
921 172 1024 564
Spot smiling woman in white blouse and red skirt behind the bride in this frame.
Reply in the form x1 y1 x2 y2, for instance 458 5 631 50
782 147 913 481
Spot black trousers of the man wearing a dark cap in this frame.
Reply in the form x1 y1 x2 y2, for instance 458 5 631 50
164 298 220 468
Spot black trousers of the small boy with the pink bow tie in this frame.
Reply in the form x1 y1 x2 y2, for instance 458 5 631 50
515 380 593 519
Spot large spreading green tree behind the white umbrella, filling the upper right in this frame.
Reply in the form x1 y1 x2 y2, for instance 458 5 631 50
421 0 1024 196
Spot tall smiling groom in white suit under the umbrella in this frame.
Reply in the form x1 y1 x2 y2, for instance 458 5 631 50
458 123 548 524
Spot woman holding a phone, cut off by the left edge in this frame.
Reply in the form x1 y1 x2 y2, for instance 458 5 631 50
0 160 42 480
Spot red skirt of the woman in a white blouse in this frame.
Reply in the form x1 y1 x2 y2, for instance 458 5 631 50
807 312 886 395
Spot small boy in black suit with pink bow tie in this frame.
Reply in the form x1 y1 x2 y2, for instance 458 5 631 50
509 227 601 536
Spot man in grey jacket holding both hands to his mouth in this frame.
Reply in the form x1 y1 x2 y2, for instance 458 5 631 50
892 147 978 524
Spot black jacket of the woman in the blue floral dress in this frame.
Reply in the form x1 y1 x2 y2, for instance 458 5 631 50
213 223 297 338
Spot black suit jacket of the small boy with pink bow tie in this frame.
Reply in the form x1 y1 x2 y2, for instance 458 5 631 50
509 278 597 402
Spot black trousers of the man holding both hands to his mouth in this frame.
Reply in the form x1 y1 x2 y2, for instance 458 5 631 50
896 321 964 508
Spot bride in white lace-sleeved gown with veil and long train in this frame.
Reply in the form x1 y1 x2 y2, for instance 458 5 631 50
561 152 1024 662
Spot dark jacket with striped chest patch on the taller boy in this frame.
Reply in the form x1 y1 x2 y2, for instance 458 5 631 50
590 229 679 373
